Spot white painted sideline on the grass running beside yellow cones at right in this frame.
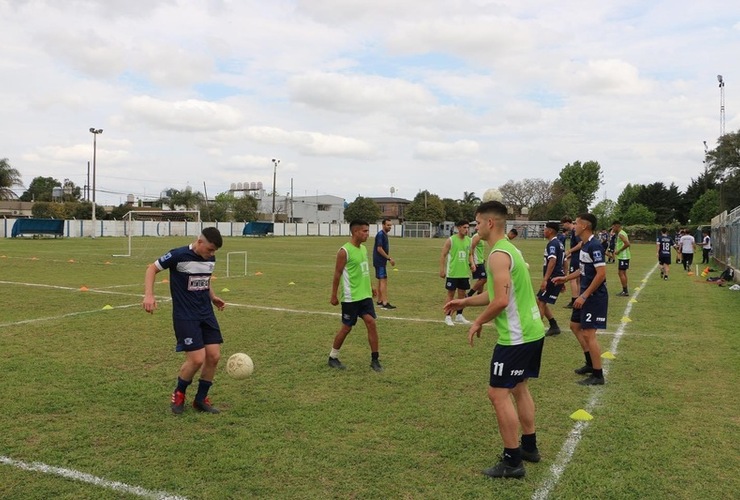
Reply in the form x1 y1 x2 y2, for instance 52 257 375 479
532 264 658 500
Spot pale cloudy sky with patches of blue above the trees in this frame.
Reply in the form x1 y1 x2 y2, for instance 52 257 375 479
0 0 740 205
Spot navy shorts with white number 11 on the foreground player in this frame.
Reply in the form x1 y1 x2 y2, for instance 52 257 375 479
488 337 545 389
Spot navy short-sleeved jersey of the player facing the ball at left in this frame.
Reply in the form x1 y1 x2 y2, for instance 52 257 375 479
154 245 216 320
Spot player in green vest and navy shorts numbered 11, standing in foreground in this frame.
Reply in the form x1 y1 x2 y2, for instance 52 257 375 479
445 201 545 477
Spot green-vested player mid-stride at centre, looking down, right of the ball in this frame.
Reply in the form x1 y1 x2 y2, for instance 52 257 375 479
329 220 383 372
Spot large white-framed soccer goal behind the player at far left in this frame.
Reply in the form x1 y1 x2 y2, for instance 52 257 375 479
113 210 200 257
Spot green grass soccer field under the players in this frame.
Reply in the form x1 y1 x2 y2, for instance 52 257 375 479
0 237 740 499
